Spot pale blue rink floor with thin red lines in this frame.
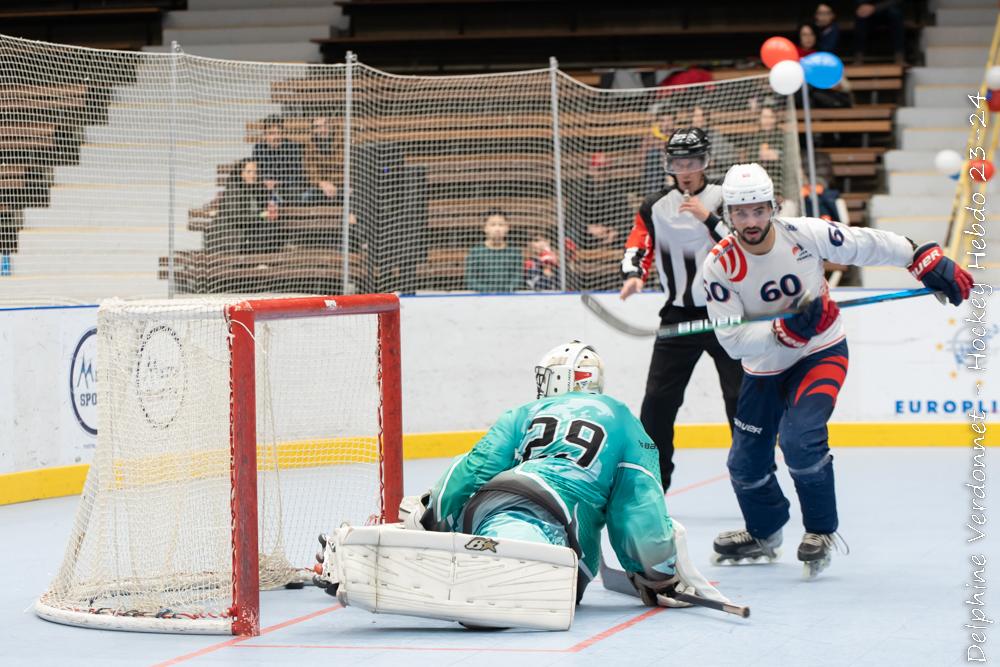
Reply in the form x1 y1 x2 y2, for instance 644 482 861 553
0 448 1000 667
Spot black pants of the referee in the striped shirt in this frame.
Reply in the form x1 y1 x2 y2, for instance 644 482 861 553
639 306 743 491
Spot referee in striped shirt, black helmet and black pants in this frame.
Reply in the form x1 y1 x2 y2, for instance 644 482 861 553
621 128 743 490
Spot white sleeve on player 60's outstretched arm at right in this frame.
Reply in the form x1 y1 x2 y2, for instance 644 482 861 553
783 218 914 267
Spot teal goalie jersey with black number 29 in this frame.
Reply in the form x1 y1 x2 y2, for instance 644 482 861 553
425 392 675 578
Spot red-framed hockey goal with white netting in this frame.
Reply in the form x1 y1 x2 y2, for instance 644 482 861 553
36 294 402 635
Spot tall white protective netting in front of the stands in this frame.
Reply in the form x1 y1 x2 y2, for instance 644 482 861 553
0 32 799 301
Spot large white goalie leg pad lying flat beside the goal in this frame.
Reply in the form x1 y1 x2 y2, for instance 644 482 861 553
324 524 577 630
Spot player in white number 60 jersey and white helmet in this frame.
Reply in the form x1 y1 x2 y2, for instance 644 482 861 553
703 164 972 576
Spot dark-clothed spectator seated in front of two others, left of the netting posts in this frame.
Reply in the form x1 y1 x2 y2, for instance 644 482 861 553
205 159 280 254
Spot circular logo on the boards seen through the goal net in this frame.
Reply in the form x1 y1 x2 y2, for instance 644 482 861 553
135 326 187 428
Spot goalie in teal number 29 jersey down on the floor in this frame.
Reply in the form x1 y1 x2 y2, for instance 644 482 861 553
317 341 728 630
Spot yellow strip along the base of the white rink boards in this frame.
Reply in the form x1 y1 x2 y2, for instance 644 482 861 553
0 422 1000 505
